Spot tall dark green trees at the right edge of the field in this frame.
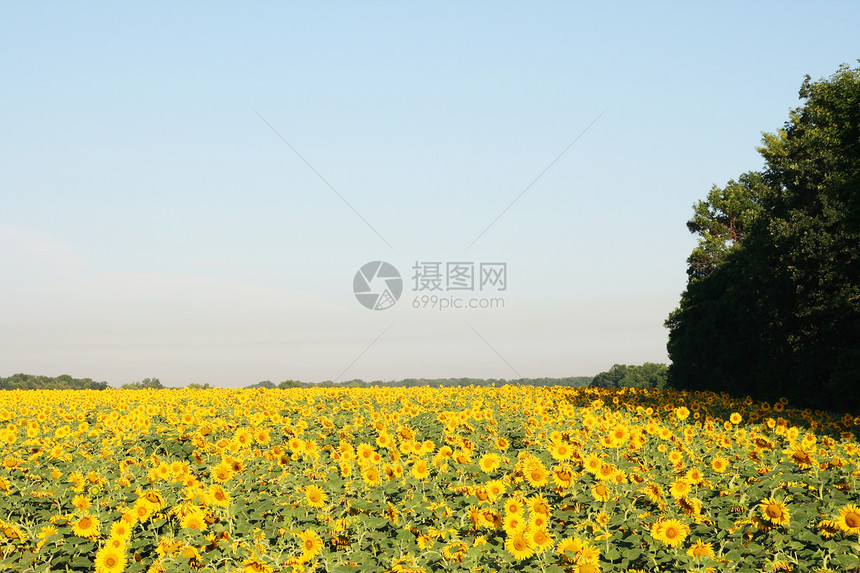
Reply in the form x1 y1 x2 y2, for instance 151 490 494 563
666 66 860 409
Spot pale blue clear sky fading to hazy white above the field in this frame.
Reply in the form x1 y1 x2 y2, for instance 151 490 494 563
0 1 860 386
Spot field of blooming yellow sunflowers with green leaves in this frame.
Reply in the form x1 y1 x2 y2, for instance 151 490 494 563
0 386 860 573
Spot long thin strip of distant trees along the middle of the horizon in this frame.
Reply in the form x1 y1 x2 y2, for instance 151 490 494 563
246 376 592 388
